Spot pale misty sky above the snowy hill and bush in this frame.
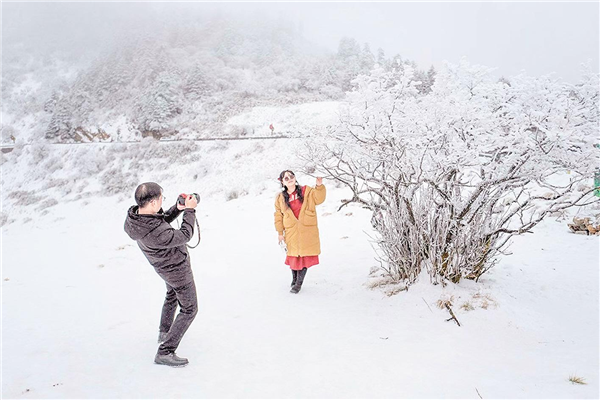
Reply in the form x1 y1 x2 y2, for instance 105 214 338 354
2 2 600 81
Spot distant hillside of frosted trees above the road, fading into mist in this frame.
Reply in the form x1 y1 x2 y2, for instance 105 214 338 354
2 19 435 142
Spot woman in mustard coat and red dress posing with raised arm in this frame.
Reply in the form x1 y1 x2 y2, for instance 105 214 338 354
275 170 326 293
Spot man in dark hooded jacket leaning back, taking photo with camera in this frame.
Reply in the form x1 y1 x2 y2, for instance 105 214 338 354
125 182 198 367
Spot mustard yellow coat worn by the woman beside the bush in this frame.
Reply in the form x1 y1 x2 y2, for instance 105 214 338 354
275 185 327 257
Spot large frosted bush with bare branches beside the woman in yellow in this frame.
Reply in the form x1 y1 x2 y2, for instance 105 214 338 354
307 60 599 285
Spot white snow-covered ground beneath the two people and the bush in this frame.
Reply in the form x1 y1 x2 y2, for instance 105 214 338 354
2 104 599 398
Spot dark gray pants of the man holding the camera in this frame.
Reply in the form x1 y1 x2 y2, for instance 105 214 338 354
158 279 198 355
